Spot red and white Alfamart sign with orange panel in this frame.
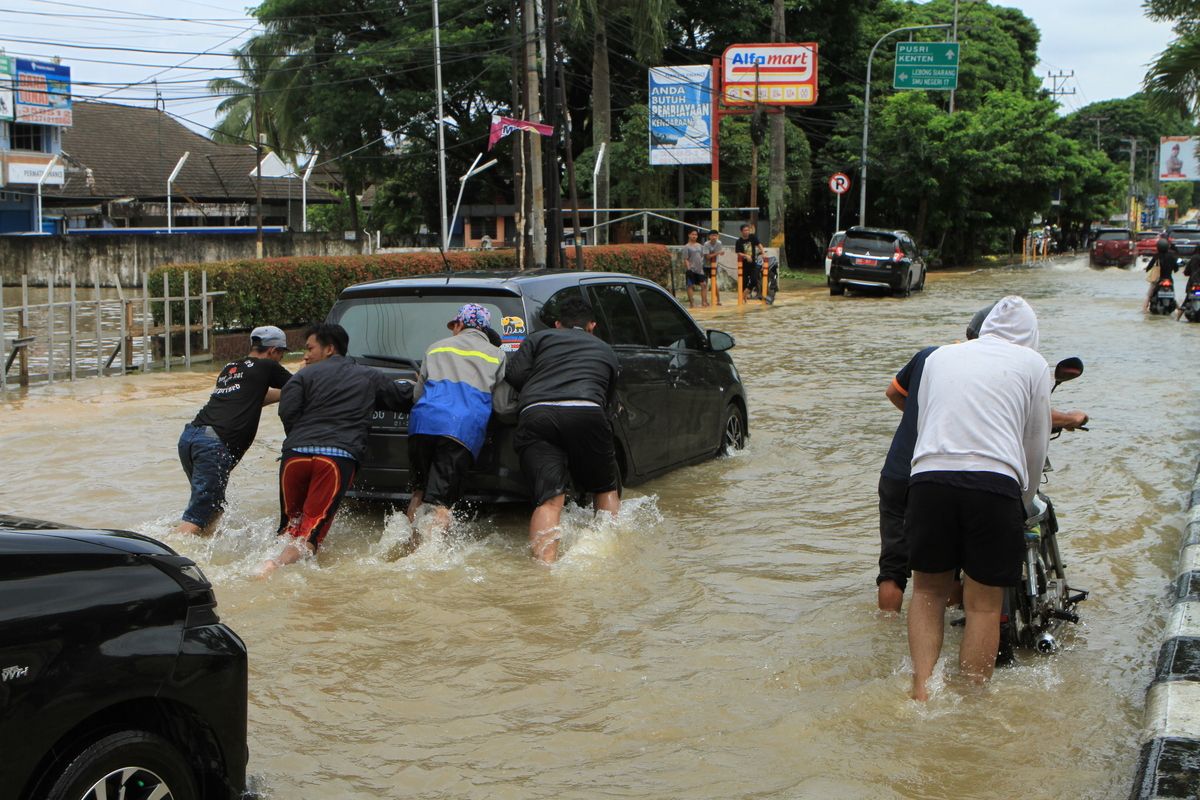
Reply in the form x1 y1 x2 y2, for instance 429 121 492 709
721 42 817 106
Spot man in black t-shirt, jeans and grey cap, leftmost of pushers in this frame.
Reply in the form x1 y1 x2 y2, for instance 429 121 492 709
175 325 292 534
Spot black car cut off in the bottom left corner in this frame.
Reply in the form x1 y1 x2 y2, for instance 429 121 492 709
0 516 247 800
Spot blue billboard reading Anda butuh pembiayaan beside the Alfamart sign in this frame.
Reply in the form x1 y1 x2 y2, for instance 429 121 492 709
650 66 713 166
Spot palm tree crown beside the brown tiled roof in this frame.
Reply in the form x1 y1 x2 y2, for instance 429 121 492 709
209 35 306 166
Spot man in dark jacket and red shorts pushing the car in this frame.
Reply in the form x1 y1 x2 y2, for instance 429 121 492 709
259 323 413 577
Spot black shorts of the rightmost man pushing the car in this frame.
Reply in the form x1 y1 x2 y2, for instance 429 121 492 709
512 405 617 505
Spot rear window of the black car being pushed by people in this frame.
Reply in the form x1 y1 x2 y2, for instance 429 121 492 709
329 293 526 362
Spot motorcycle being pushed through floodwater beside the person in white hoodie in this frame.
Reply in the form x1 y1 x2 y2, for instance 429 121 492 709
996 357 1088 664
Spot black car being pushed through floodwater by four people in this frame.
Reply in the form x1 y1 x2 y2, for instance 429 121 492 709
328 270 749 503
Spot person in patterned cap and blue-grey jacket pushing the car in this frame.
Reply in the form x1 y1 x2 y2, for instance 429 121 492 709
408 302 504 545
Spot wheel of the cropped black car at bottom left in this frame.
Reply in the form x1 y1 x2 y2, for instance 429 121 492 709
46 730 200 800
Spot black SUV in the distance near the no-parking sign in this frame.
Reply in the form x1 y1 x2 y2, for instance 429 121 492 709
828 227 925 297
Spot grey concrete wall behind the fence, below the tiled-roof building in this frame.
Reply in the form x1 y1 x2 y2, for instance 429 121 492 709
0 233 359 287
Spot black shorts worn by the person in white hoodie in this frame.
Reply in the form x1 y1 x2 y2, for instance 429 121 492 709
904 482 1025 587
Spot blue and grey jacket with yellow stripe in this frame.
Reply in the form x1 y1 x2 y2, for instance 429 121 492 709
408 327 504 458
